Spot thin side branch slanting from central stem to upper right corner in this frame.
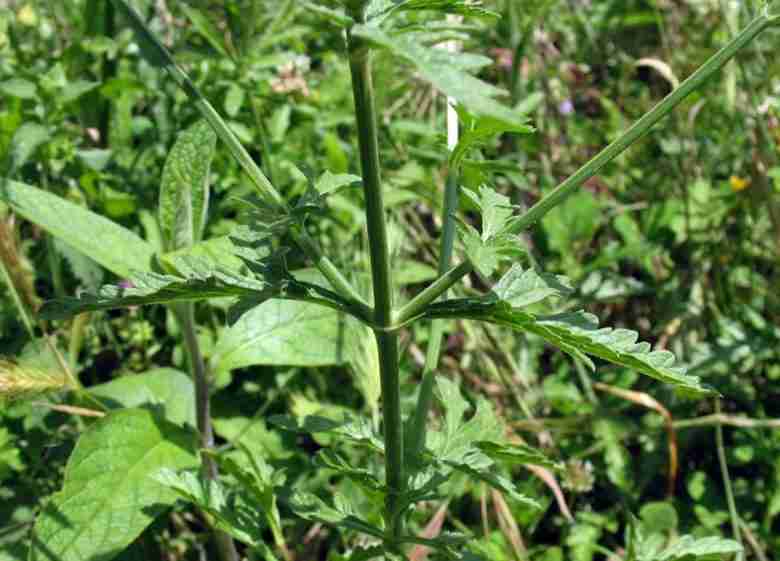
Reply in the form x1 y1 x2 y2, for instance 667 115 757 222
397 12 780 310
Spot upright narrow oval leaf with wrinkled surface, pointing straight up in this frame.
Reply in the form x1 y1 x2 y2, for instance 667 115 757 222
158 121 217 251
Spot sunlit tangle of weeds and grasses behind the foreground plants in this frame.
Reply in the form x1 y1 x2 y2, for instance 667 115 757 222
0 0 780 561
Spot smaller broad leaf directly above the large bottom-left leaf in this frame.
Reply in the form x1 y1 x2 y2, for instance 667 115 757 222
87 368 195 427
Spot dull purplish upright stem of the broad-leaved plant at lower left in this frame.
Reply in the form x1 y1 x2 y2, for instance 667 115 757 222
173 303 239 561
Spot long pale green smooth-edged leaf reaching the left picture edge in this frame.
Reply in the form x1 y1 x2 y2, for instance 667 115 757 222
0 178 154 277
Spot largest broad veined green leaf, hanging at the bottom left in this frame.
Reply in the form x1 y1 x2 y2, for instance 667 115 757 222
30 409 197 561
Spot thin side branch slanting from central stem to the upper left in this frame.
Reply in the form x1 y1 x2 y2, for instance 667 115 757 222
114 0 364 304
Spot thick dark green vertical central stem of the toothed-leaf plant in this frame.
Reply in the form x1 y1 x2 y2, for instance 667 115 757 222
347 7 406 540
